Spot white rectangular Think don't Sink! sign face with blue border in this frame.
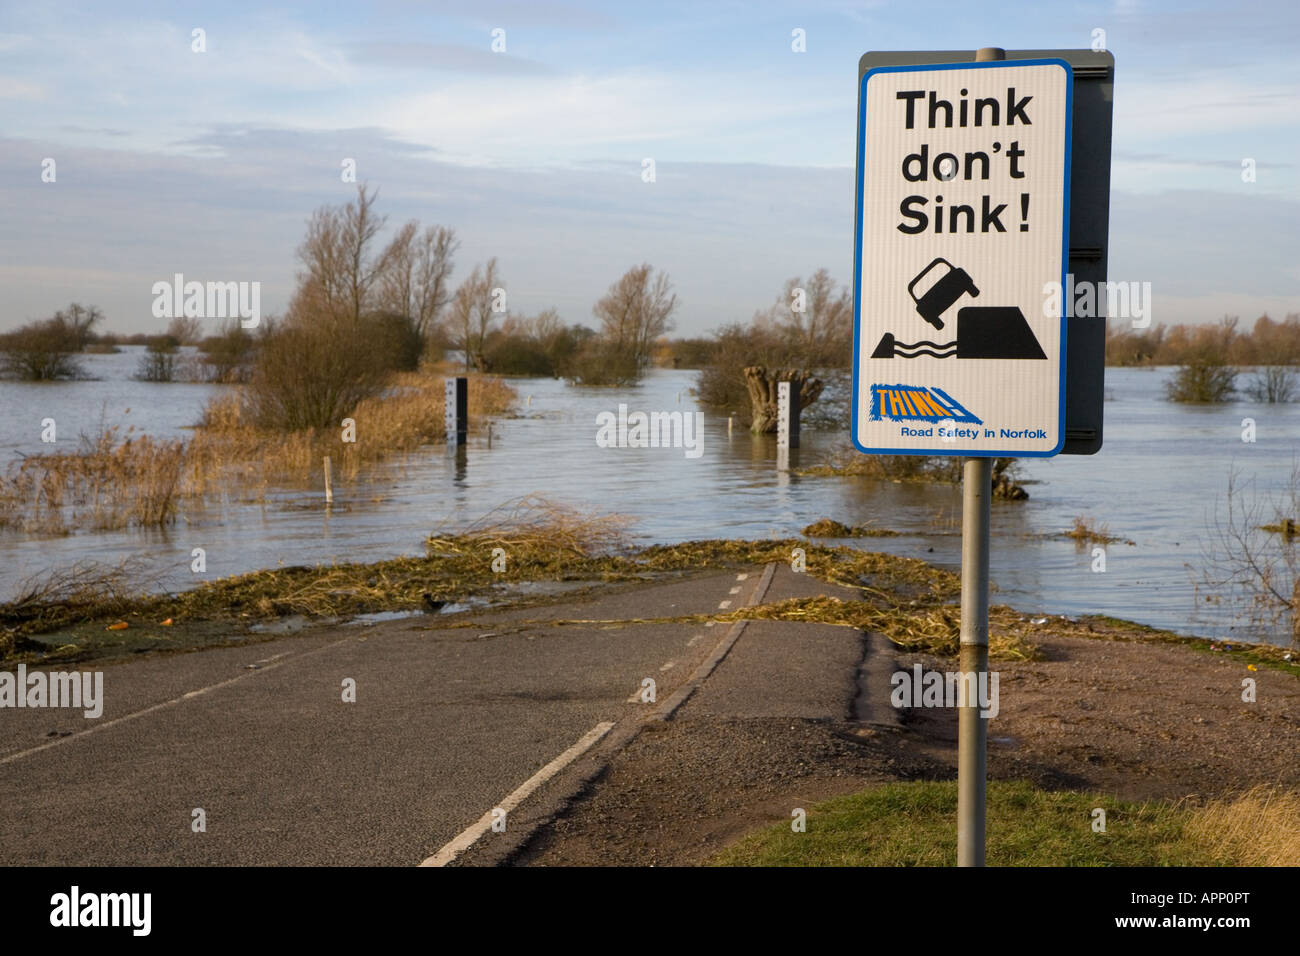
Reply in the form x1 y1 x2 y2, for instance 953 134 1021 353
853 59 1074 458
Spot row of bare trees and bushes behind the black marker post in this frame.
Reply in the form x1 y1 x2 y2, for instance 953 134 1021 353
246 185 676 431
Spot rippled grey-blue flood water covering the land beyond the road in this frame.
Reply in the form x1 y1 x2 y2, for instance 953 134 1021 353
0 349 1300 643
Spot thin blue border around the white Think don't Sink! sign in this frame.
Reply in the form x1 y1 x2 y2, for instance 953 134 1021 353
849 57 1074 458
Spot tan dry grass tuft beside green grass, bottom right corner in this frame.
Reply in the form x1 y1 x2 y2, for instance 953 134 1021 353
1186 784 1300 866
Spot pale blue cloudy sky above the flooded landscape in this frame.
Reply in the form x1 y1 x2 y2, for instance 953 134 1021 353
0 0 1300 336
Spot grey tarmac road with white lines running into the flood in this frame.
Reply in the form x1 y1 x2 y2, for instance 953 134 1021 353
0 566 863 865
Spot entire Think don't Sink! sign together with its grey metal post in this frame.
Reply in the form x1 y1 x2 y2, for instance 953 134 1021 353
852 47 1113 866
